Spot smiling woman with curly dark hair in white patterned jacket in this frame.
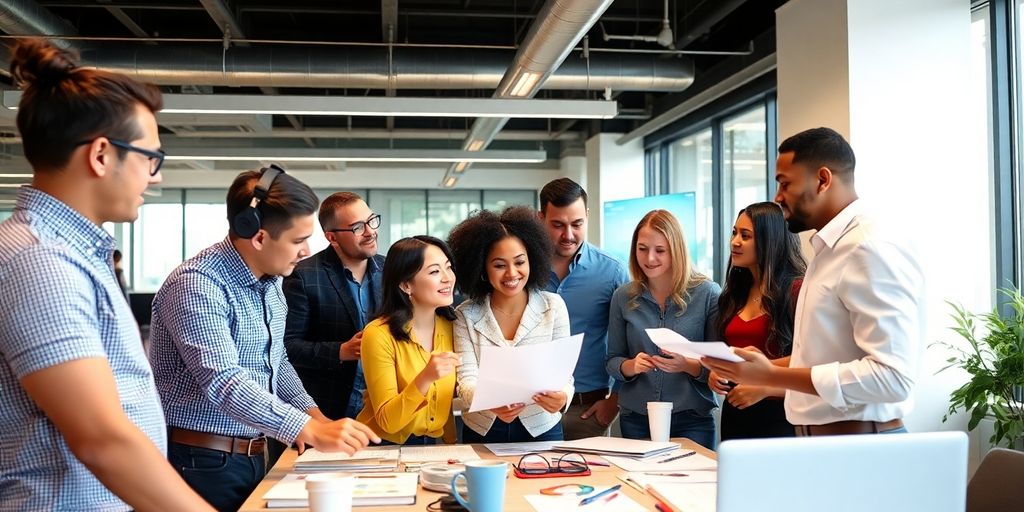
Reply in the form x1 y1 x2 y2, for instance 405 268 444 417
449 206 573 442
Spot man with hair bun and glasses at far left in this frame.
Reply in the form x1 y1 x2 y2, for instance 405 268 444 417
0 39 210 511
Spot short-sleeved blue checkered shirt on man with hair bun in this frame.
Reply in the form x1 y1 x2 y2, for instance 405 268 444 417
0 186 167 511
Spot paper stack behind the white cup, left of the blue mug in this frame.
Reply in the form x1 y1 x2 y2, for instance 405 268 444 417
263 473 419 509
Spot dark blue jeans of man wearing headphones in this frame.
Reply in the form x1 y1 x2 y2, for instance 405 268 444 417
167 442 266 512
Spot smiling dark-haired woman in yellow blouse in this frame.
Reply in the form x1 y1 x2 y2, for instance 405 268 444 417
356 236 460 444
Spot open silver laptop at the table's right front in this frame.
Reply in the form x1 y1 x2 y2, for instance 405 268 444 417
717 432 968 512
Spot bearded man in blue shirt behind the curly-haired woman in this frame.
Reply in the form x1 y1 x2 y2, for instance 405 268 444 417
540 178 629 439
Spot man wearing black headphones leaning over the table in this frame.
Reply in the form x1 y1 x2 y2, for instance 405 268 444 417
150 165 380 510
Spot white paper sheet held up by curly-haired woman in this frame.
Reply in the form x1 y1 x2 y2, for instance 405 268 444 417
469 334 583 413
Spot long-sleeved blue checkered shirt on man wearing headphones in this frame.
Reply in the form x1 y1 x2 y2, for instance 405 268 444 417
150 239 316 444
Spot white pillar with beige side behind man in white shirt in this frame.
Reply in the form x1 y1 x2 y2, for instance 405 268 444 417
776 0 992 468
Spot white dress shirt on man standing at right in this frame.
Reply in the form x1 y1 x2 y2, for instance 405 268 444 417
785 201 926 425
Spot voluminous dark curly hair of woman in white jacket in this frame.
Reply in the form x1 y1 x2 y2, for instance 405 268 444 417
447 206 554 300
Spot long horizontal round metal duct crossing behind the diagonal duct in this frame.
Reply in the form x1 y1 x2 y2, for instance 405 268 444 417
74 45 693 92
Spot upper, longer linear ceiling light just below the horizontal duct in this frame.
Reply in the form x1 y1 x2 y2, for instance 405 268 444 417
3 92 618 119
